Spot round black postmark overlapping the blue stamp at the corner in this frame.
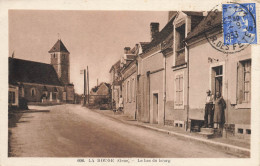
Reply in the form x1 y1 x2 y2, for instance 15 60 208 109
203 3 256 54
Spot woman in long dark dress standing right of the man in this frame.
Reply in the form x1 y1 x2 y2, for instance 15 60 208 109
214 92 226 128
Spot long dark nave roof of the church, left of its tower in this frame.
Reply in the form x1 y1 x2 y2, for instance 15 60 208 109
9 57 61 86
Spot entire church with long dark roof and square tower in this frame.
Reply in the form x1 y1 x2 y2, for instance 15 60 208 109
9 40 74 105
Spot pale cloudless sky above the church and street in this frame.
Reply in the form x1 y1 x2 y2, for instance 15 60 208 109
9 10 168 94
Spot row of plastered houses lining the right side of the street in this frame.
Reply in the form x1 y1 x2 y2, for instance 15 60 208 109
110 11 251 138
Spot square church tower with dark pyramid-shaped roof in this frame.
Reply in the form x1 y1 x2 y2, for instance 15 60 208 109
49 39 70 85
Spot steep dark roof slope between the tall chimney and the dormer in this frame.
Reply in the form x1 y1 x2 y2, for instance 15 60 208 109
144 15 176 52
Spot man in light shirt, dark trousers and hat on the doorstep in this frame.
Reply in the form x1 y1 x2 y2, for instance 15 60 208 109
203 90 214 128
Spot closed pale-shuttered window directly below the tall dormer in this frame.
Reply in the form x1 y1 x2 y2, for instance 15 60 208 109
175 74 183 106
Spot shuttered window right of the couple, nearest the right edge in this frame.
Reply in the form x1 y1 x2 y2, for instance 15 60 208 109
237 60 251 104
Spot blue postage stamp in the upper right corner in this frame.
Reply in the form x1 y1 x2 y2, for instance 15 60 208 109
222 3 257 45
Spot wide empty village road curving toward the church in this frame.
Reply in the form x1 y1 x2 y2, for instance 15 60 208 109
10 104 239 158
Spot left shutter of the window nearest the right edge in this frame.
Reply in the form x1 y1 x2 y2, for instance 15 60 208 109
237 62 244 104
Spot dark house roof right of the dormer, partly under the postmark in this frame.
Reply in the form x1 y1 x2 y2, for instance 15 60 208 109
185 12 222 40
